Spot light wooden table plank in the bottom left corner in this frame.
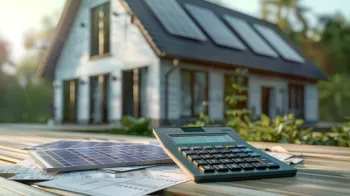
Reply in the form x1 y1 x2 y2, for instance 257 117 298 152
0 177 55 196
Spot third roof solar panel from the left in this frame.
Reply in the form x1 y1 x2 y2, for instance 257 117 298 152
224 15 278 57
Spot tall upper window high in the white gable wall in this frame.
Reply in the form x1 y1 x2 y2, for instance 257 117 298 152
90 3 110 56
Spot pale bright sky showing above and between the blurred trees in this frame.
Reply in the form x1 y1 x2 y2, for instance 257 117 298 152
0 0 350 62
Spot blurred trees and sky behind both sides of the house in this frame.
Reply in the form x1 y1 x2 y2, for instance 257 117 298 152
0 0 350 145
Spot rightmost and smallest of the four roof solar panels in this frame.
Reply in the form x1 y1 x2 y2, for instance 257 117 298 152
254 24 304 63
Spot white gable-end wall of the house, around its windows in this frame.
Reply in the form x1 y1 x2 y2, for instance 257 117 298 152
54 0 160 122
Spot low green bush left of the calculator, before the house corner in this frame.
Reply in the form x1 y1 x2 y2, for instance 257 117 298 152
108 116 152 136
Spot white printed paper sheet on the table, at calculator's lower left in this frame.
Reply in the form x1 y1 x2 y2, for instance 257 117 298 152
37 166 189 196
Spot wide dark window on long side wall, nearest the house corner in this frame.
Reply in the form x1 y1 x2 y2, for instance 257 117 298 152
181 70 208 117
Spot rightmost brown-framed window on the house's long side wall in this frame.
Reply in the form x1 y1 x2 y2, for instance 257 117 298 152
288 84 304 118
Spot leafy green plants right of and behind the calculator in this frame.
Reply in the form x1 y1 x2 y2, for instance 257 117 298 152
186 77 350 146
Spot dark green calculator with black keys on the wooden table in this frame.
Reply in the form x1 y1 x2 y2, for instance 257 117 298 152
153 127 297 182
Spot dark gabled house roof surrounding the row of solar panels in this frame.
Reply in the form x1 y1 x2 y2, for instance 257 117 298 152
39 0 327 81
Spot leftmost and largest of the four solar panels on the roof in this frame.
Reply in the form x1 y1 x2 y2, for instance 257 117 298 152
145 0 206 41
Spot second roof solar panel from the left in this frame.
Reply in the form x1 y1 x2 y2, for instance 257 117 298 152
185 4 246 50
